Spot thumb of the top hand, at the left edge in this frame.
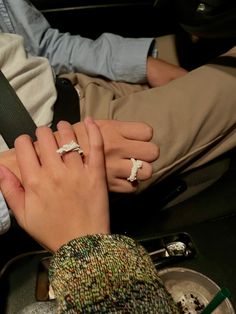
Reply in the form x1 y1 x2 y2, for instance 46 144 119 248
0 165 25 220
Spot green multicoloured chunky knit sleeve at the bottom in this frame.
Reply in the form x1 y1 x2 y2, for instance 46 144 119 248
49 235 178 314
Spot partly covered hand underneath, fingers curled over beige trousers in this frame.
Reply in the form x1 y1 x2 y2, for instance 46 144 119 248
0 120 159 193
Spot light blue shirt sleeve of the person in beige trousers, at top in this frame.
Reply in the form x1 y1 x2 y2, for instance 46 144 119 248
6 0 153 83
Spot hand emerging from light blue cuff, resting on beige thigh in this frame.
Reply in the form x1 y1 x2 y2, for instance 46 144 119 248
147 57 188 87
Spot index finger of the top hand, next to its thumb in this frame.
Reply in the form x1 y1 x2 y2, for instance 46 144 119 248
15 135 40 183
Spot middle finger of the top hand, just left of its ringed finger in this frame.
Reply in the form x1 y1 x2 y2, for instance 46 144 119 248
36 126 62 169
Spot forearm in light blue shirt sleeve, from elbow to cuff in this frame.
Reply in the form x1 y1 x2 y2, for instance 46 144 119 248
43 32 153 83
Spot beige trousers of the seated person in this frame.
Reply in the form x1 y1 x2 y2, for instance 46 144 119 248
62 36 236 200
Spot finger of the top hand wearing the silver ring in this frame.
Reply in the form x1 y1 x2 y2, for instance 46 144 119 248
57 121 83 167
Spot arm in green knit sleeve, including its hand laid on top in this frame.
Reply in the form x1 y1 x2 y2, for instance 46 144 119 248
0 119 177 313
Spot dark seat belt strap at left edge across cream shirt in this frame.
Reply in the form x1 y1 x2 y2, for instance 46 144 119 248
0 71 37 148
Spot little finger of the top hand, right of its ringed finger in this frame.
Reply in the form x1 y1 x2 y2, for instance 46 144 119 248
84 117 106 176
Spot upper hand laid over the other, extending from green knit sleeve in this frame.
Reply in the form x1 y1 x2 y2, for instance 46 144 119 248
0 118 109 251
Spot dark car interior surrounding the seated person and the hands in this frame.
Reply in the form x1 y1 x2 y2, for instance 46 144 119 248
0 0 236 314
